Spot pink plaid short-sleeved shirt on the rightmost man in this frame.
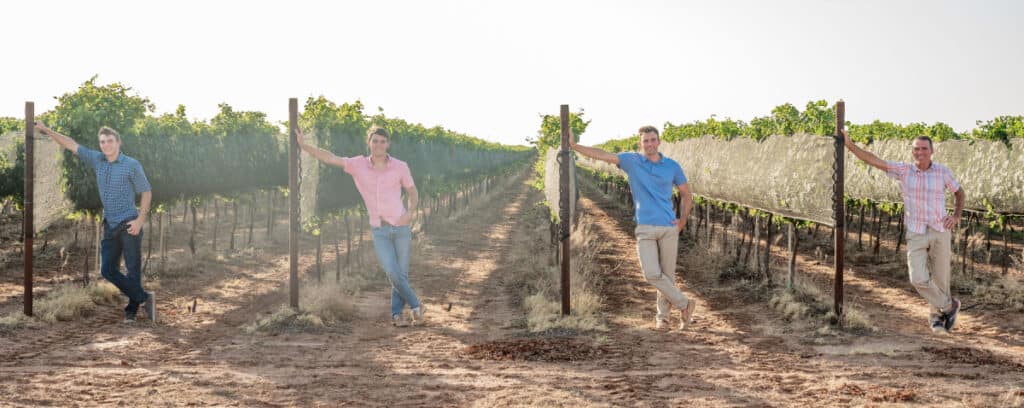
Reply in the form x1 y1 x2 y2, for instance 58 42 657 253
886 162 959 234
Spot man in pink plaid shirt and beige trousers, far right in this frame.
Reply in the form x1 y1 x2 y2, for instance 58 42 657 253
842 130 964 333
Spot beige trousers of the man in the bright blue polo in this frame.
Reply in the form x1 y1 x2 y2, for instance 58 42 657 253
636 225 689 320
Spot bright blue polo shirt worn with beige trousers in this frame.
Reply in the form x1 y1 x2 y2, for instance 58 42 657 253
618 152 686 227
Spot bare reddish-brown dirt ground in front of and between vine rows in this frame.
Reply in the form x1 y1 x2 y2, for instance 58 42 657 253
0 167 1024 407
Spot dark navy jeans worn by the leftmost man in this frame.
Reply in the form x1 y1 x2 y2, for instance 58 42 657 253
99 219 147 315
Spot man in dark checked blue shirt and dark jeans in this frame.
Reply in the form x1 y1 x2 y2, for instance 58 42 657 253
36 122 157 323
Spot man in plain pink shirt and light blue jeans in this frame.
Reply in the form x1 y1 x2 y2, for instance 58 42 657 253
296 126 424 327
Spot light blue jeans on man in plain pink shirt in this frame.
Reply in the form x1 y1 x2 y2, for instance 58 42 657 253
374 226 420 317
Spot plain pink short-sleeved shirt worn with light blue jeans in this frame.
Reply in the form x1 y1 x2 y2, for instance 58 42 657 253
341 156 415 228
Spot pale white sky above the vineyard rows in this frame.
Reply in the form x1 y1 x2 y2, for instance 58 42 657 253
0 0 1024 144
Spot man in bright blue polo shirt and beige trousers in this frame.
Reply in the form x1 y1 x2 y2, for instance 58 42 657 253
569 126 696 330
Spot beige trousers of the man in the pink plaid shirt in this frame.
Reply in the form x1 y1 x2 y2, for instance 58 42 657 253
906 227 952 317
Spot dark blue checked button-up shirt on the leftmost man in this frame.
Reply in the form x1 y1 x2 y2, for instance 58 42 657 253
78 145 153 223
